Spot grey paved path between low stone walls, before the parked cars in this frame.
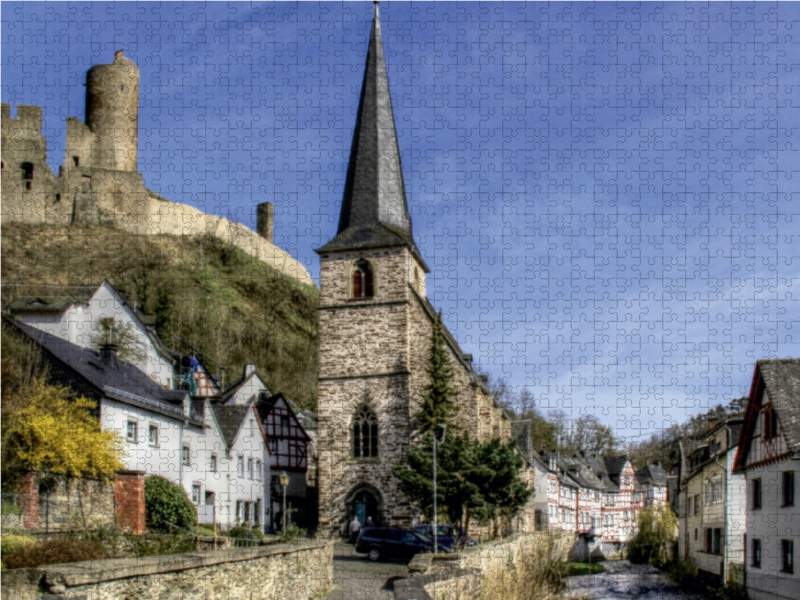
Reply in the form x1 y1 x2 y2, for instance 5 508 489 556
325 544 408 600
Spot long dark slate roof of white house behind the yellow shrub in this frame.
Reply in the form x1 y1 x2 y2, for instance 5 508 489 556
4 317 194 425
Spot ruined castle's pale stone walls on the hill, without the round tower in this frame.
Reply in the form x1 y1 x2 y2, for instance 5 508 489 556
0 98 314 285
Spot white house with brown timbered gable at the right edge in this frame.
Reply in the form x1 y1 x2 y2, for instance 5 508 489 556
734 358 800 600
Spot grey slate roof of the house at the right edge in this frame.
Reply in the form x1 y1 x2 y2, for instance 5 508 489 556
758 358 800 452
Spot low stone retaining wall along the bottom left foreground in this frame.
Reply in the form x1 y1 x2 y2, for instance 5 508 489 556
2 542 333 600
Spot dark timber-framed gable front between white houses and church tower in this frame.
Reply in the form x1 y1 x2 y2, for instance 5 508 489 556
256 394 311 472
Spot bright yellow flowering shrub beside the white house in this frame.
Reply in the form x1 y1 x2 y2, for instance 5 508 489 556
2 380 124 479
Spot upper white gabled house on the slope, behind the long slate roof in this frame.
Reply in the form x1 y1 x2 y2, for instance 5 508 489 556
7 281 178 389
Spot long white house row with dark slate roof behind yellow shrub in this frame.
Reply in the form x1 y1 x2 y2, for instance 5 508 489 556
5 318 270 527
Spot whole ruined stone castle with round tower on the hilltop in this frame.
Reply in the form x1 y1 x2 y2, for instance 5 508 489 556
0 51 314 285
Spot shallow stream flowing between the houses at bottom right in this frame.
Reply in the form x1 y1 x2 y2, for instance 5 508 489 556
562 560 708 600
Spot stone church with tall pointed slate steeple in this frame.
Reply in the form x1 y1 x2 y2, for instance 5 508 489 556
316 3 534 537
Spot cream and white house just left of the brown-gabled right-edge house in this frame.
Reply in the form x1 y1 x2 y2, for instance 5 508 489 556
678 415 745 583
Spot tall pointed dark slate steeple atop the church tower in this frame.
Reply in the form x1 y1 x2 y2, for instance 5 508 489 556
317 2 424 264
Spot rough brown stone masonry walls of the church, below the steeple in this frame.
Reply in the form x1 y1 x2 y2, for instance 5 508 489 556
318 247 528 535
